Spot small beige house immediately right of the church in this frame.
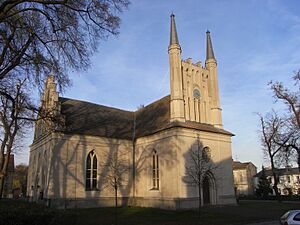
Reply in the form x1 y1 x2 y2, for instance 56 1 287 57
232 161 257 195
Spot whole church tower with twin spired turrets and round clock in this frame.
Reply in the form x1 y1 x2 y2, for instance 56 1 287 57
168 14 222 128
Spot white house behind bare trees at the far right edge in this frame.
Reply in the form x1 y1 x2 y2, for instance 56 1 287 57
254 167 300 195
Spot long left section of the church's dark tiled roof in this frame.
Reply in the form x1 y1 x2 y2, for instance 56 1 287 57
59 98 133 139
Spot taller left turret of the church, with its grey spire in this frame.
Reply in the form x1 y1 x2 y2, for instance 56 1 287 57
168 14 185 122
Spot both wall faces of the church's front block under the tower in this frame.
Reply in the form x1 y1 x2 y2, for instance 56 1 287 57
135 128 235 207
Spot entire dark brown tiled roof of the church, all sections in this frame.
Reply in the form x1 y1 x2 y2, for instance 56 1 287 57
59 95 233 140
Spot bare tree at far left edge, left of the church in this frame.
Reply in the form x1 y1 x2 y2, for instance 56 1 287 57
0 79 33 198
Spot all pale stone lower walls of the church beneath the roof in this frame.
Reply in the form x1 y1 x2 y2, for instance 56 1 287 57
28 128 235 208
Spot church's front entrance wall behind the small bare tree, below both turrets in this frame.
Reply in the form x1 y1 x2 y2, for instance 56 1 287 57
177 129 235 204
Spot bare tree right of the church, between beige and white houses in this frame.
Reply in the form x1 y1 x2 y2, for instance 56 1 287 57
258 111 290 200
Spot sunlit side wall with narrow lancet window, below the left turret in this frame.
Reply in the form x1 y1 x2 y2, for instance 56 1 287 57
135 130 178 198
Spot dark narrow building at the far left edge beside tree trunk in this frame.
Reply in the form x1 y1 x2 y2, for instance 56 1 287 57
2 154 15 198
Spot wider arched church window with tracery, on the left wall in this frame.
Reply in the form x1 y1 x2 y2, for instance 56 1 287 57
85 150 97 190
